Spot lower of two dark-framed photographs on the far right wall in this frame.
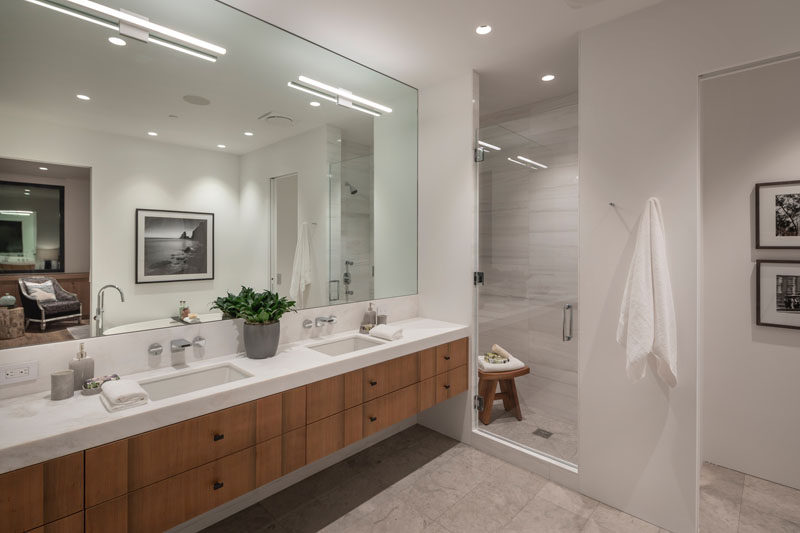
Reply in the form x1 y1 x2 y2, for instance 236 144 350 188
756 261 800 329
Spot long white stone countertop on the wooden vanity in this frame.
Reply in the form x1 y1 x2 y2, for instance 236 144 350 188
0 318 469 473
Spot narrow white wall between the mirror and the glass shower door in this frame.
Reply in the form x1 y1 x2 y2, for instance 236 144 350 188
419 72 478 441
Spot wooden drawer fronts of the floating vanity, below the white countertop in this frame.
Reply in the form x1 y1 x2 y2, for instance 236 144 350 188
14 339 468 533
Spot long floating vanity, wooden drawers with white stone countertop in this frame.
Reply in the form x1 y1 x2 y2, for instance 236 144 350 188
0 319 469 533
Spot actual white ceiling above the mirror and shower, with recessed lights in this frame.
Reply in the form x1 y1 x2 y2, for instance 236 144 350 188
225 0 660 113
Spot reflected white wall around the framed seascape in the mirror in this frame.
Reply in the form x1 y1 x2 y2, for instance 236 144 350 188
0 112 242 328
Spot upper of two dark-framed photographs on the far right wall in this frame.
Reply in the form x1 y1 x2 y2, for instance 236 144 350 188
756 181 800 248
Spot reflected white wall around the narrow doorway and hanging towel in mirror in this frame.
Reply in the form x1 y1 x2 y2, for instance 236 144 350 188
239 126 329 307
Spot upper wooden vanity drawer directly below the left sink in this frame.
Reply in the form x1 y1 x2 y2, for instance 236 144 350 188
128 402 256 491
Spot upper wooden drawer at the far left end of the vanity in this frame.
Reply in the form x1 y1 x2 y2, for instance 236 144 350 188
0 452 83 532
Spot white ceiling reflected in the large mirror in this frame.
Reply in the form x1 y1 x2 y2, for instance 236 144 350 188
0 0 416 154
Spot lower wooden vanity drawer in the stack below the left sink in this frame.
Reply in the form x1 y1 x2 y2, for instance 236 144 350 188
126 447 256 533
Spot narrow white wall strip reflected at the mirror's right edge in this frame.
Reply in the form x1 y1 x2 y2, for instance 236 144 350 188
373 92 418 298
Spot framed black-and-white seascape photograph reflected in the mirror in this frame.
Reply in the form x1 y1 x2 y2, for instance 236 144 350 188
136 209 214 283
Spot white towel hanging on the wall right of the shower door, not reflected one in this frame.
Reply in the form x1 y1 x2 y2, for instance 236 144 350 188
617 198 678 387
